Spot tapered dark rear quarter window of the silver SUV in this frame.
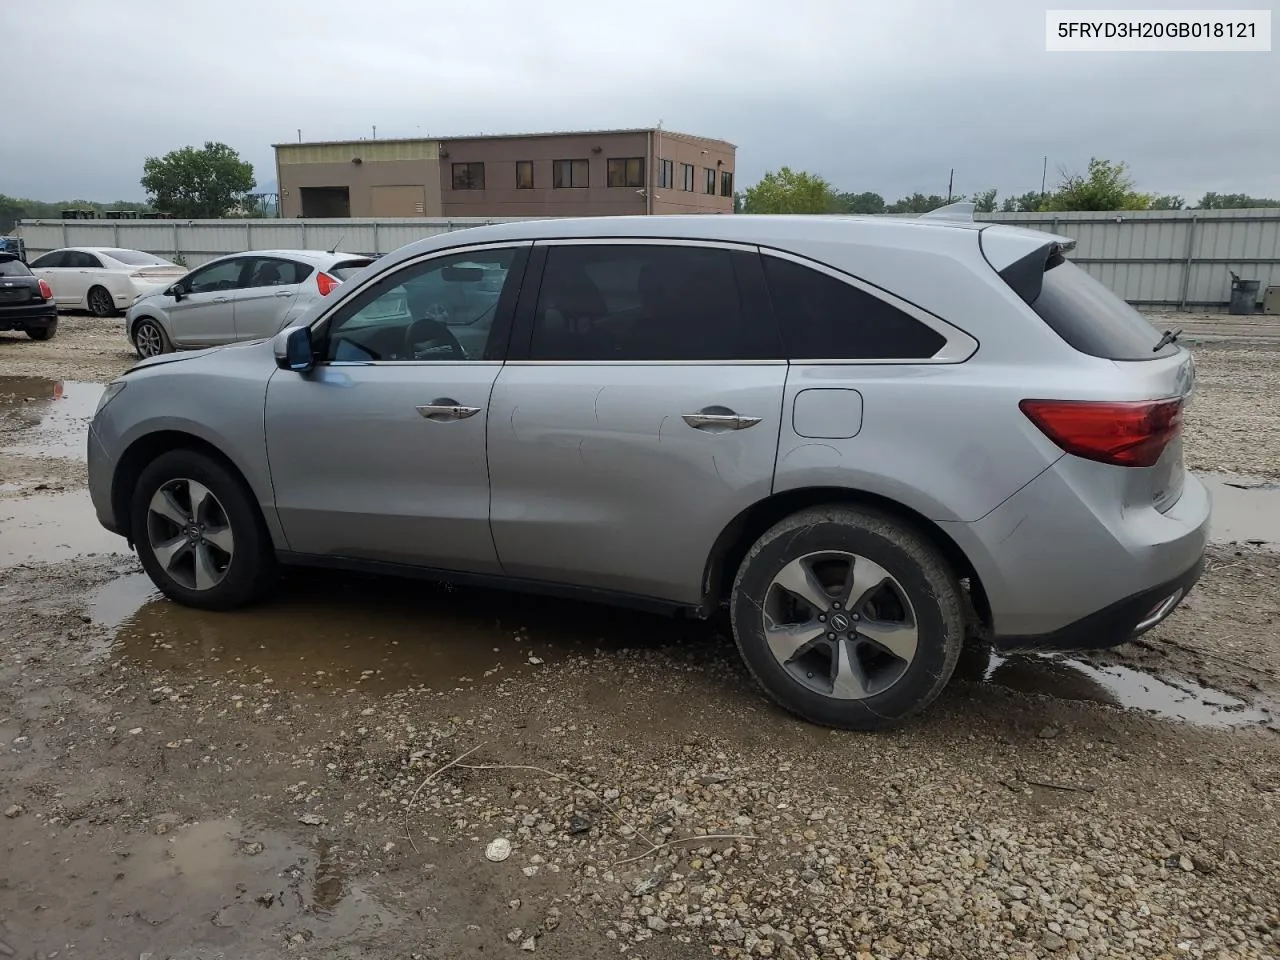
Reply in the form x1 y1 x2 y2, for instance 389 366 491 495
764 256 946 361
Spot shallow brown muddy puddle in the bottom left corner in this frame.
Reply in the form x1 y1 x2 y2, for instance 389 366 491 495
0 815 399 956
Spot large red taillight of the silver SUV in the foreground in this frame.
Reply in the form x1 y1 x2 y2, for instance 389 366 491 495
1018 398 1183 467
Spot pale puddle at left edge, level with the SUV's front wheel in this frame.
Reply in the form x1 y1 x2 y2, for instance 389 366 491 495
0 490 128 570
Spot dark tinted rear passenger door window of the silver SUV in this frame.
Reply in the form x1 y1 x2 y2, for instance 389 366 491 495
530 243 778 361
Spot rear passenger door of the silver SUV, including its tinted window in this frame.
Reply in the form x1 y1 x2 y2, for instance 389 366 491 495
489 241 787 603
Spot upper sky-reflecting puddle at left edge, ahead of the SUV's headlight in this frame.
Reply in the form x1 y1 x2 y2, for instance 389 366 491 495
0 376 102 460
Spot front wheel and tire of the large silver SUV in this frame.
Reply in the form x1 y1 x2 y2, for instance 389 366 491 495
129 449 276 611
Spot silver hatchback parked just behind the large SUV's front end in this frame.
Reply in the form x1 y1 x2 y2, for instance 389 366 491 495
124 250 372 357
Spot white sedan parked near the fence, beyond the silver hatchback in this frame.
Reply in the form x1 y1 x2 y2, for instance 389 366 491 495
29 247 187 316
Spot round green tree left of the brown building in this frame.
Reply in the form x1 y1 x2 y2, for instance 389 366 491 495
142 141 255 219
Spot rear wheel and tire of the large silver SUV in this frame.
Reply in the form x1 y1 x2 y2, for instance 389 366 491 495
730 506 965 730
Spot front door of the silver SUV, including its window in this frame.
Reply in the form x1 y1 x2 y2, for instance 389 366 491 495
266 243 529 573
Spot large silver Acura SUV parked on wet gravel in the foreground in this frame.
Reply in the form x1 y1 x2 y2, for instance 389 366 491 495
88 216 1210 728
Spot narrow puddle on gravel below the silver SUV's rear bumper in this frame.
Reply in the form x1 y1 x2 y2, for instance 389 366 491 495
982 654 1277 730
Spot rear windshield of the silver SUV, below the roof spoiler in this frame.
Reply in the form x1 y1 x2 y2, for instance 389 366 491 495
1032 260 1178 360
